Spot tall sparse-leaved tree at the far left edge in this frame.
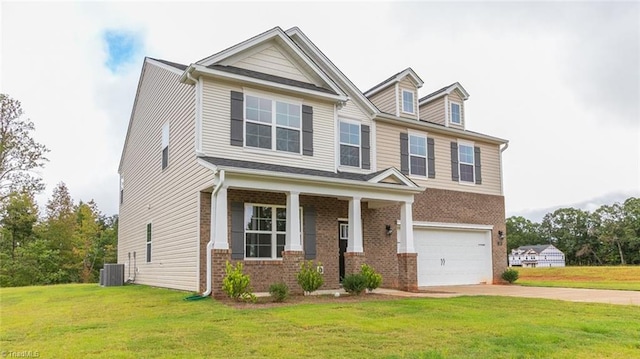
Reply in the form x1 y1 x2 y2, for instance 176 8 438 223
0 94 49 201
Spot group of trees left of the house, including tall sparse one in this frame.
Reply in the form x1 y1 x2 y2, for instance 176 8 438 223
0 94 118 287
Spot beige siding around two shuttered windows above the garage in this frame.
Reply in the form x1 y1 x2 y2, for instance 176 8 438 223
376 123 502 195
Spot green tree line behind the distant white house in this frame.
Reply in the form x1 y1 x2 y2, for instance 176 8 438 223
507 197 640 265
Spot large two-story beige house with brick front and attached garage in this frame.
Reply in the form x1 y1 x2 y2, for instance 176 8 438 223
118 27 507 295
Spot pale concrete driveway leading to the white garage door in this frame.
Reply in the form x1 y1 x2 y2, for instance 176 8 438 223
375 284 640 306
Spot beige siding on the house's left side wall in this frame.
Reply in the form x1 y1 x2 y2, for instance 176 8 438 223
118 63 211 290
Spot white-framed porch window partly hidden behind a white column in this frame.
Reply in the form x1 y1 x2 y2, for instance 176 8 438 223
244 204 302 259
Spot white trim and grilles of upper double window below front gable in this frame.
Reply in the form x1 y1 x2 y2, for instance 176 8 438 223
242 89 303 158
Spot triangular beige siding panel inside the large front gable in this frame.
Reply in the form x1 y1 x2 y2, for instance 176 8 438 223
233 45 313 83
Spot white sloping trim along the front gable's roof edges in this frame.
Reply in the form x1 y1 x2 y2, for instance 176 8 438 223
185 26 346 96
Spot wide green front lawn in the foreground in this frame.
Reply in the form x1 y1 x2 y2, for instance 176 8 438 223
0 285 640 358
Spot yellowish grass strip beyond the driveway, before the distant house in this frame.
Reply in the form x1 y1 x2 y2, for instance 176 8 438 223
515 266 640 290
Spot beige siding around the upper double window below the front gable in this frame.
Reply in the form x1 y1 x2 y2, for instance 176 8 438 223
202 79 336 171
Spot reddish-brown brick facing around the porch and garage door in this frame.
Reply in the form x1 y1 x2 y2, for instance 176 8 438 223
200 189 507 296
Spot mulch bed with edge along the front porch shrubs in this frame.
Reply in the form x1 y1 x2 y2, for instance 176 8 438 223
216 293 399 309
